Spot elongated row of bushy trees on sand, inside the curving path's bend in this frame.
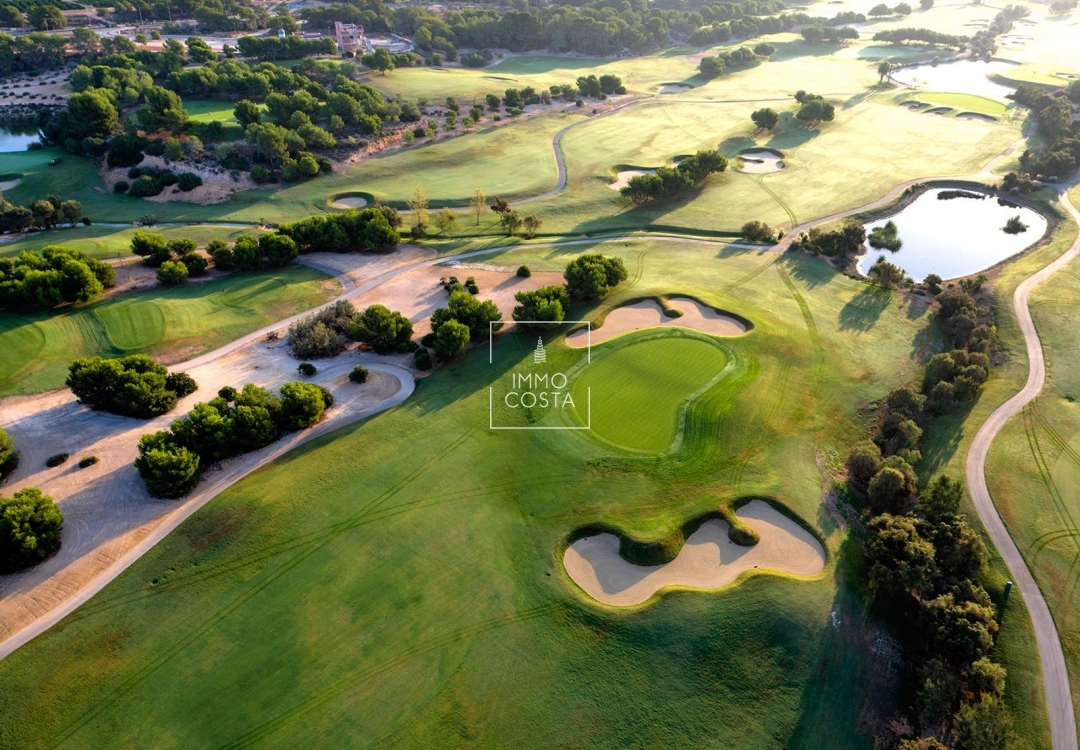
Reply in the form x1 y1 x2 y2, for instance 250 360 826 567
135 380 334 497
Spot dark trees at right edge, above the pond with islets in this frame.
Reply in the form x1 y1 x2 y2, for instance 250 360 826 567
1008 81 1080 180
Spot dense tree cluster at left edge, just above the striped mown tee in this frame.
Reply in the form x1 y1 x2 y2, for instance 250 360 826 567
0 245 116 309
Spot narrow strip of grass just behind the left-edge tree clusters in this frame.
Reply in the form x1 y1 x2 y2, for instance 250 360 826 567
0 224 264 258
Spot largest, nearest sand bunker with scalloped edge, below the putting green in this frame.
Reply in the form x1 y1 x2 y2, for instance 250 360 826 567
563 500 825 606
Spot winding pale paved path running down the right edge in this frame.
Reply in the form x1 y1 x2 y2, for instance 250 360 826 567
964 179 1080 750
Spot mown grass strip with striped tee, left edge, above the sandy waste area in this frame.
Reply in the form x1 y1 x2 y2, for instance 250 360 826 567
0 266 340 397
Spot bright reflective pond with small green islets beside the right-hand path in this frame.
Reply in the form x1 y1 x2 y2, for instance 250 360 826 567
858 188 1047 281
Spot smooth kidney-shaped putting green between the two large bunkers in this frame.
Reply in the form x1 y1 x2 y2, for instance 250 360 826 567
570 331 728 452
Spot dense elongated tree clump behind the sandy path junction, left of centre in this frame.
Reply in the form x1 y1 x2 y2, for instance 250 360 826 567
276 205 402 253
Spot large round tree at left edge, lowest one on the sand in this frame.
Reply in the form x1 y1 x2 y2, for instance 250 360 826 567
0 490 64 573
